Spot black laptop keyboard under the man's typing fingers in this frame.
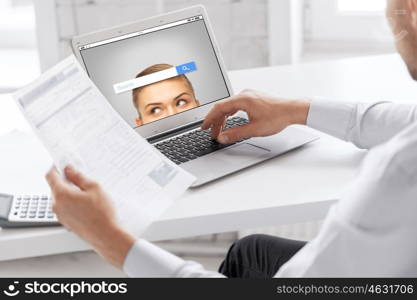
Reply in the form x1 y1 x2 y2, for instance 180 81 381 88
155 117 248 165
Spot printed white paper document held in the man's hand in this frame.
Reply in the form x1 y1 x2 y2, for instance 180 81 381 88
14 56 194 235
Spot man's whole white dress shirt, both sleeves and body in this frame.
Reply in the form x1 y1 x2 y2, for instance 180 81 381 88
124 101 417 277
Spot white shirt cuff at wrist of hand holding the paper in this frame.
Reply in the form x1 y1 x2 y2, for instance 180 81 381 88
123 239 185 277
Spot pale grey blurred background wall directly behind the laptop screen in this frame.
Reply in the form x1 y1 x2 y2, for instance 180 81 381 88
35 0 272 69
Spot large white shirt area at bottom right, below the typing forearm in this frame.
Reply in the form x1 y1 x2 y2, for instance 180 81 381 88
276 120 417 277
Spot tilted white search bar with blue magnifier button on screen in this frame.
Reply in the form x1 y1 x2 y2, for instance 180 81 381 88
113 61 197 94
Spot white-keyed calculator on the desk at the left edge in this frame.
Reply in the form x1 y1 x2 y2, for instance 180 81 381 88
0 194 59 228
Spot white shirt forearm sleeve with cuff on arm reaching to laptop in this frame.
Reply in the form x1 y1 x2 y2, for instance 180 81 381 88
307 99 417 149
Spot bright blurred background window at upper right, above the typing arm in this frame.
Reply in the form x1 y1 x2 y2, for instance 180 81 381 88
304 0 395 61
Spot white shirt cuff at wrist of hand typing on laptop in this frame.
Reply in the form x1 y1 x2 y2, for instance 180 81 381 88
307 99 356 140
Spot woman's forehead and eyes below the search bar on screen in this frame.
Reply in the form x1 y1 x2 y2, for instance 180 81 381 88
132 69 200 126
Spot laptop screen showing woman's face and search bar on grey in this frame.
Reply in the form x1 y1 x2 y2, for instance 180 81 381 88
79 15 230 128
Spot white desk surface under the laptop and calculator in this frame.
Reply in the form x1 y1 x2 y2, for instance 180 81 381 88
0 55 417 260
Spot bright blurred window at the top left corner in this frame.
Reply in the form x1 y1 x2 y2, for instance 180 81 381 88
0 0 40 93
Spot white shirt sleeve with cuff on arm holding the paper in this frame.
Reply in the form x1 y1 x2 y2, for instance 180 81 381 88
123 239 224 278
